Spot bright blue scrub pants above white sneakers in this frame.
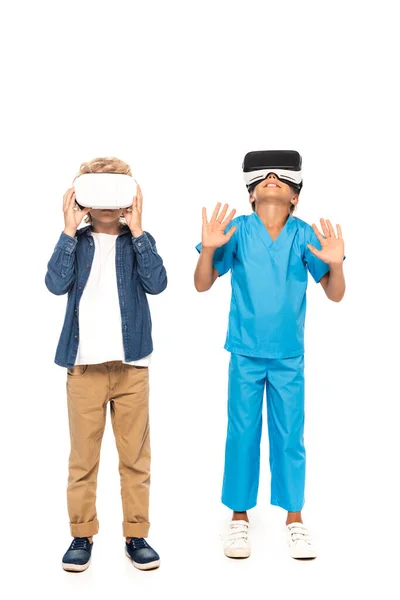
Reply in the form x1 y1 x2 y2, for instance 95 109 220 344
222 354 306 512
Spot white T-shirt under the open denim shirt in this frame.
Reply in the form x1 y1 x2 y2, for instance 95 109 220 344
75 232 151 367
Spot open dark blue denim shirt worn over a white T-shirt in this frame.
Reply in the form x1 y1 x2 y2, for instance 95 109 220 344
45 225 167 368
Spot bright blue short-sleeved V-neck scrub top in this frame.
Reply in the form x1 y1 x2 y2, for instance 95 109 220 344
196 212 329 358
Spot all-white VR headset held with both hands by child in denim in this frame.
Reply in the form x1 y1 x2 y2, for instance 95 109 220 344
74 173 137 209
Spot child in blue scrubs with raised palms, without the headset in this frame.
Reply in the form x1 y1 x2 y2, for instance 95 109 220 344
195 152 345 558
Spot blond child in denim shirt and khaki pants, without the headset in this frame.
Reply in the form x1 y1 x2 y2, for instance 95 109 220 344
45 157 167 571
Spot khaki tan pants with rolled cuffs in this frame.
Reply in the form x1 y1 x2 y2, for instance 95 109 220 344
67 360 150 537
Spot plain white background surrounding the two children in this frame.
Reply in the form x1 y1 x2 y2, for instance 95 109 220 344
0 0 400 599
